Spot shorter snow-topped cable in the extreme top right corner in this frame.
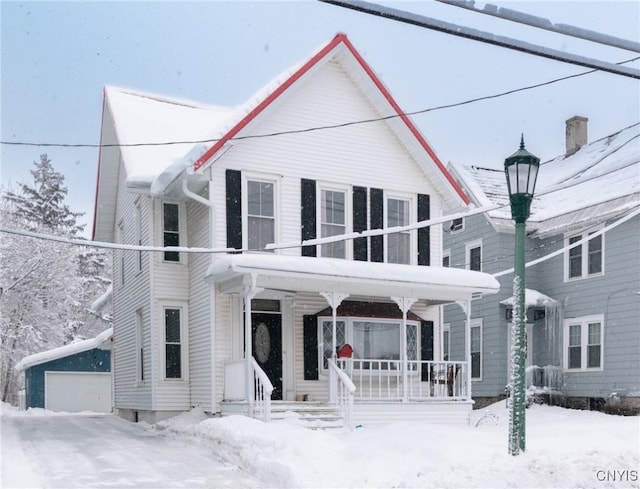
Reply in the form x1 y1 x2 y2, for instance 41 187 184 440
436 0 640 53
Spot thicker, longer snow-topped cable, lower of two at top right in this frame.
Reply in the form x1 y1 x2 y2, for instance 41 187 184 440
320 0 640 80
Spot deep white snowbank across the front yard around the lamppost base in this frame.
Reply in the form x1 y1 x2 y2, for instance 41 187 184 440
2 403 640 488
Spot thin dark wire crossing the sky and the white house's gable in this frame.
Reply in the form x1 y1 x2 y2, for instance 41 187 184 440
0 56 640 148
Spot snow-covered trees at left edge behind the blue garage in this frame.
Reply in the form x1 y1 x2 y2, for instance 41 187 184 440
0 155 110 402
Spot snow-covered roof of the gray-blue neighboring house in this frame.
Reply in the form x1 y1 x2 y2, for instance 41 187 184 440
450 123 640 236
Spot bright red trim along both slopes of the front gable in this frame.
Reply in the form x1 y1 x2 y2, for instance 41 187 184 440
193 33 470 205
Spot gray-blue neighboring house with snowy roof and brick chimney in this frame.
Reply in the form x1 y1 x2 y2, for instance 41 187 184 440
442 117 640 414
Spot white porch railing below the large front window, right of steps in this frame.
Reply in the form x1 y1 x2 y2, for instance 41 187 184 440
337 358 471 401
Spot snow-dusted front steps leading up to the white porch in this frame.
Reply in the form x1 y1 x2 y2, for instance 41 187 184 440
271 401 344 430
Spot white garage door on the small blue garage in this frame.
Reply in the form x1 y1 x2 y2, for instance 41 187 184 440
44 372 111 413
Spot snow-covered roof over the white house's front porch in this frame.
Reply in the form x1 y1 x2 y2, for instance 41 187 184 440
207 253 500 304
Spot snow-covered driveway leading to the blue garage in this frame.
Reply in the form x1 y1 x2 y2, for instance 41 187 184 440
0 415 263 489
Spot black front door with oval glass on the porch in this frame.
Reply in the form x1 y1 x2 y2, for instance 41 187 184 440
251 312 282 401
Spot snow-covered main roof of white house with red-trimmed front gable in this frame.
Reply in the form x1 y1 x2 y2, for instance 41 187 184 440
93 34 469 240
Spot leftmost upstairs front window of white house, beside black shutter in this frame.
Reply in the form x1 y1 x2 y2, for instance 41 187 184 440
246 180 276 251
